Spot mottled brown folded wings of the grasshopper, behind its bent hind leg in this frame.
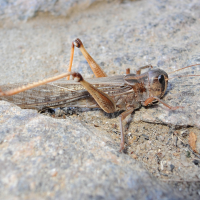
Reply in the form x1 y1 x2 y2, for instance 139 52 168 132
0 75 132 110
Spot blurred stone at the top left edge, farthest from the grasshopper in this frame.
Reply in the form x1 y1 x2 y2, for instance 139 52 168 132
0 0 105 21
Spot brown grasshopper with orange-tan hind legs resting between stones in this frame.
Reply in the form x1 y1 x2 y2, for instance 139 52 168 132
0 38 199 152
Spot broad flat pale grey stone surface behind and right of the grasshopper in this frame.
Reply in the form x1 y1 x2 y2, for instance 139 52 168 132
0 1 200 127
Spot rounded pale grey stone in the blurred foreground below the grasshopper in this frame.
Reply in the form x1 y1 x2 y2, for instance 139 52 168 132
0 101 181 199
